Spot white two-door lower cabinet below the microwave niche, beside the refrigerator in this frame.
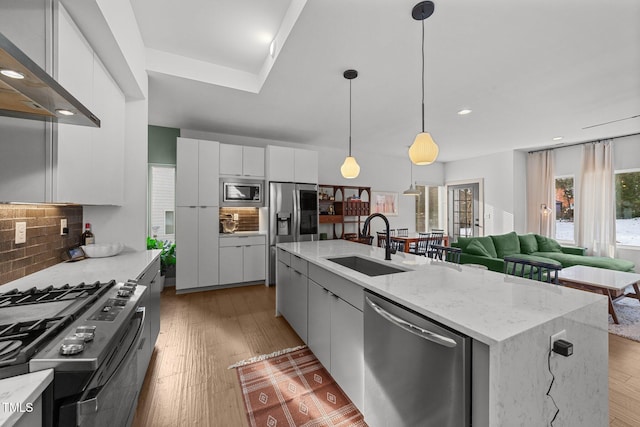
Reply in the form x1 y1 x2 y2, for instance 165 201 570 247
219 236 267 285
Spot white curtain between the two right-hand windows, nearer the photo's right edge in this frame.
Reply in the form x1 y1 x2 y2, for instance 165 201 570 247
576 140 616 257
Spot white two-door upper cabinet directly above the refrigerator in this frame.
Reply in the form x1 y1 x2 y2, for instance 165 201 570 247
267 145 318 184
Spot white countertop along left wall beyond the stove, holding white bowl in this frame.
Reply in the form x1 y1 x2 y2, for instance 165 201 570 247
0 249 161 292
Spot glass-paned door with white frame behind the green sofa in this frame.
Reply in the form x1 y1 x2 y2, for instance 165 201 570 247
447 182 482 242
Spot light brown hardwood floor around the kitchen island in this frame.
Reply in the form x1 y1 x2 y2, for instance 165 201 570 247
133 285 640 427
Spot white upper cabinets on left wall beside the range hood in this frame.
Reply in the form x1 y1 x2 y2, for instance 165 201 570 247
53 5 126 205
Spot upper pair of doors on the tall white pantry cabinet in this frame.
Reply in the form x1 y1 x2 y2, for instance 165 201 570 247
176 138 220 206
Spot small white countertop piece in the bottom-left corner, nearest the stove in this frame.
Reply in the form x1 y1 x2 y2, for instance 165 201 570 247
0 369 53 427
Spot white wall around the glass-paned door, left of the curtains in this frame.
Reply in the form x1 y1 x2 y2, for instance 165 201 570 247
444 151 526 235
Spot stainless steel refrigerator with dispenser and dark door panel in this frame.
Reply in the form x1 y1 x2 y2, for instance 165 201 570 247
269 182 318 284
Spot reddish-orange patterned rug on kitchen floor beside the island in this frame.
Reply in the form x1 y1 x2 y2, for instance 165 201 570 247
229 347 366 427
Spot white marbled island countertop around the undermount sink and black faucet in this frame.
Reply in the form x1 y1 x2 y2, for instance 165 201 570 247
278 240 605 345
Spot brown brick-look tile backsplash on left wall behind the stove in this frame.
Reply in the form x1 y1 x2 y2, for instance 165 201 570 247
0 205 82 285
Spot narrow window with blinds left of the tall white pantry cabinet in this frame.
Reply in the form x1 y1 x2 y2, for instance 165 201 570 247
149 165 176 242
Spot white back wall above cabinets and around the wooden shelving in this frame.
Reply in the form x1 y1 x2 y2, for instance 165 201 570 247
180 129 444 232
